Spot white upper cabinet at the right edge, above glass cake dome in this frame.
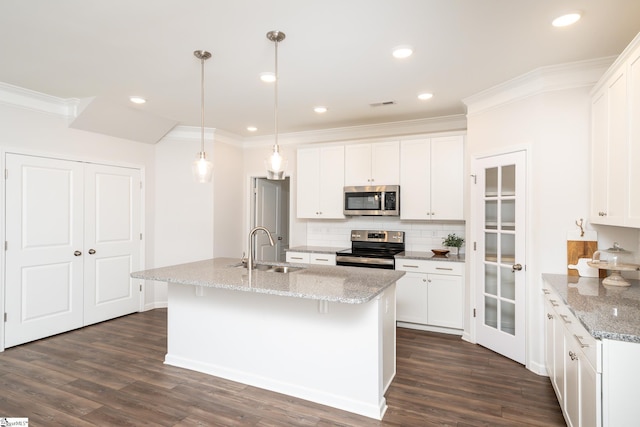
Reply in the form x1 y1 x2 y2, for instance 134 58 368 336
591 32 640 228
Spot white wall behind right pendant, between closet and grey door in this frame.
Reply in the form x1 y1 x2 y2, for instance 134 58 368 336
148 127 243 308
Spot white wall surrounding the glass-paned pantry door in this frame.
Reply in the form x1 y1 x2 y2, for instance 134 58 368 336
467 60 638 373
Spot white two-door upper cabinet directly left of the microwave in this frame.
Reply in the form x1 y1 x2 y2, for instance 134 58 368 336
297 145 344 219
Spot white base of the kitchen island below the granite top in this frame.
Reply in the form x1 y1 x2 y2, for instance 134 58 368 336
165 283 395 419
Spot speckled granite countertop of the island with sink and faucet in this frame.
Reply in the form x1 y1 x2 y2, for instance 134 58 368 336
131 258 404 304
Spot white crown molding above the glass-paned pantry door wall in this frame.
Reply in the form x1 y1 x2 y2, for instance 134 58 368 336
462 56 616 117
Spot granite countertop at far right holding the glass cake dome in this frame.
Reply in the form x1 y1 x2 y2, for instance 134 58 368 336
542 274 640 343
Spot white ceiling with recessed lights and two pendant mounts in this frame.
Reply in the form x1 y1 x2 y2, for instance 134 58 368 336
0 0 640 140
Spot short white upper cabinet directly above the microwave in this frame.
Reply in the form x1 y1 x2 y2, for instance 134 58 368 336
344 141 400 186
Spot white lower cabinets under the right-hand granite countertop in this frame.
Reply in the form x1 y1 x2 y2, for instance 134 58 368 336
543 289 600 427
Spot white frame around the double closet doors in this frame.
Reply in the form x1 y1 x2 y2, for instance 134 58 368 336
0 146 147 352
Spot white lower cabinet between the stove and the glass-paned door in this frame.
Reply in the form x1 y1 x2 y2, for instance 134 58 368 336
396 259 464 334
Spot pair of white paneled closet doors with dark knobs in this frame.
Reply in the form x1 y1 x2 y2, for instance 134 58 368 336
5 154 141 347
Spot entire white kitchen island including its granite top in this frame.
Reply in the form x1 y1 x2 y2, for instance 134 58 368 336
131 258 404 419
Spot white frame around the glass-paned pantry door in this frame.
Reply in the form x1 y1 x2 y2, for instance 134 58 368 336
467 144 539 372
